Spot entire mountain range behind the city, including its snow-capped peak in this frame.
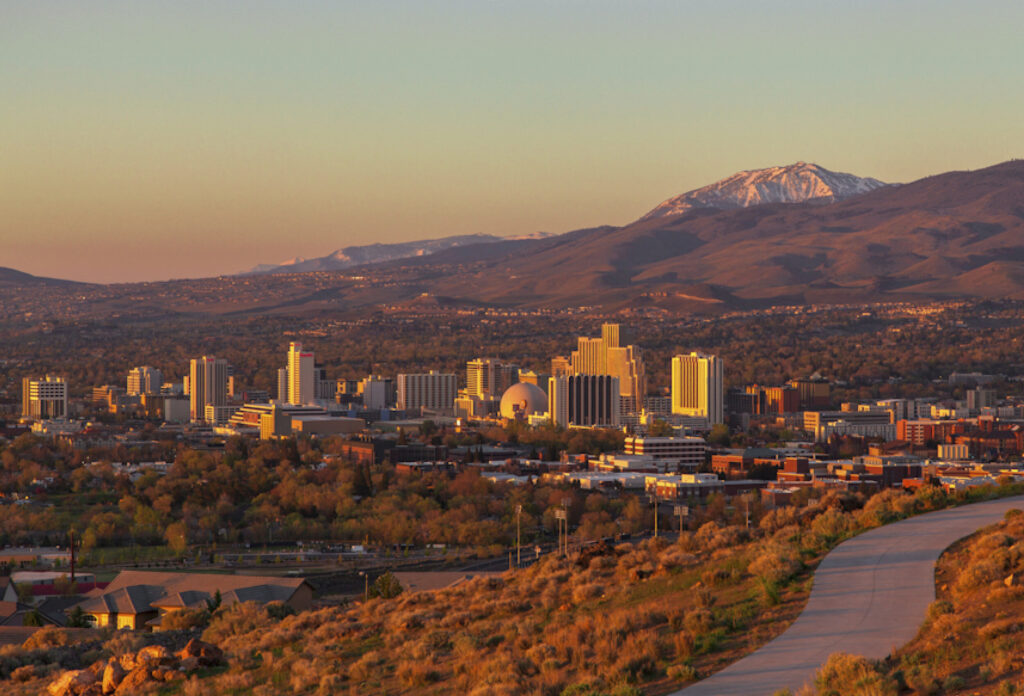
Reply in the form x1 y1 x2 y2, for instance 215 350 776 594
6 160 1024 315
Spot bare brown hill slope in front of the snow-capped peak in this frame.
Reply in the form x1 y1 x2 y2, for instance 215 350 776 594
409 161 1024 304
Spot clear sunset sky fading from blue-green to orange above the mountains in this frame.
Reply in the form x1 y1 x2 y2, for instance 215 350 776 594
0 0 1024 282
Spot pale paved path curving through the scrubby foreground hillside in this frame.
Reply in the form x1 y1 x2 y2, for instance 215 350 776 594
673 496 1024 696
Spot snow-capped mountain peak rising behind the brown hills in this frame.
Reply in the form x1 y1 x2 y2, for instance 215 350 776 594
640 162 888 220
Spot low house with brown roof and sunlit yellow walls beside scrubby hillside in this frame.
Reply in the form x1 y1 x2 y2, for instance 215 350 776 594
76 570 313 630
